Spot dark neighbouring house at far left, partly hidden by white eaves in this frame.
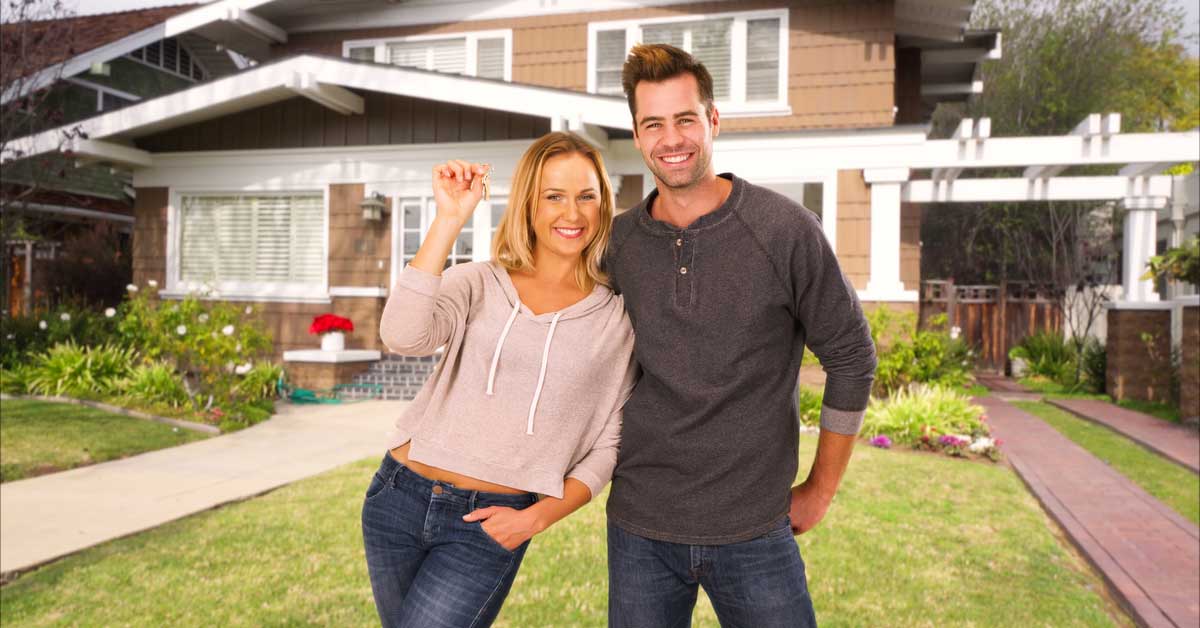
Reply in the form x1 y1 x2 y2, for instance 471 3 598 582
0 5 246 315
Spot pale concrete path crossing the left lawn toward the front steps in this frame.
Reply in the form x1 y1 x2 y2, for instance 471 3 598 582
0 401 407 575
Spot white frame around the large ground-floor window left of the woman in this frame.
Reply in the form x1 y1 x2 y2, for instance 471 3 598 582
160 185 330 303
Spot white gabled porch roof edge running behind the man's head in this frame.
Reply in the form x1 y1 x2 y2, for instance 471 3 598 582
0 54 631 165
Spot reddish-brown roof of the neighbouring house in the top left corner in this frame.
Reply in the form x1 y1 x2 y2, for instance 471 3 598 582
0 4 199 79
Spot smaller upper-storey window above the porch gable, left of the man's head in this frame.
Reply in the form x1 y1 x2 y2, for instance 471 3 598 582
342 30 512 80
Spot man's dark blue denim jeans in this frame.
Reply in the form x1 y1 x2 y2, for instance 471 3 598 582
608 516 817 628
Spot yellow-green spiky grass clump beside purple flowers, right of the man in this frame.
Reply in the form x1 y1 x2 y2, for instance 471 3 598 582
860 384 991 453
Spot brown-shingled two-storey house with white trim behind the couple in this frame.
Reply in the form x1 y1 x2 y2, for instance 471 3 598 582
7 0 1196 396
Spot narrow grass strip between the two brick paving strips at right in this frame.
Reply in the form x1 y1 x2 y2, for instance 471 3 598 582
1013 401 1200 525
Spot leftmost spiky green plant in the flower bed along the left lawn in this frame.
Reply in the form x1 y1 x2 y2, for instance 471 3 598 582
26 341 137 397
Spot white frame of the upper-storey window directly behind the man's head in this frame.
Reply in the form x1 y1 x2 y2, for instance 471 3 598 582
587 8 792 118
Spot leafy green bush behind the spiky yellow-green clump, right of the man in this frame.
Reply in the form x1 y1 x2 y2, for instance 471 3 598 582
868 307 974 395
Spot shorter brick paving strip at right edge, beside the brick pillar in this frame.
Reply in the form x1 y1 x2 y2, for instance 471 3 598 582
1046 399 1200 473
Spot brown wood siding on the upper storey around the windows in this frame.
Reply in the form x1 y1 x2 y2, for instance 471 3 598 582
272 0 895 132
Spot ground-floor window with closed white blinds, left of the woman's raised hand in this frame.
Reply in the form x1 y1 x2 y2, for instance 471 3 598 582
176 193 328 294
